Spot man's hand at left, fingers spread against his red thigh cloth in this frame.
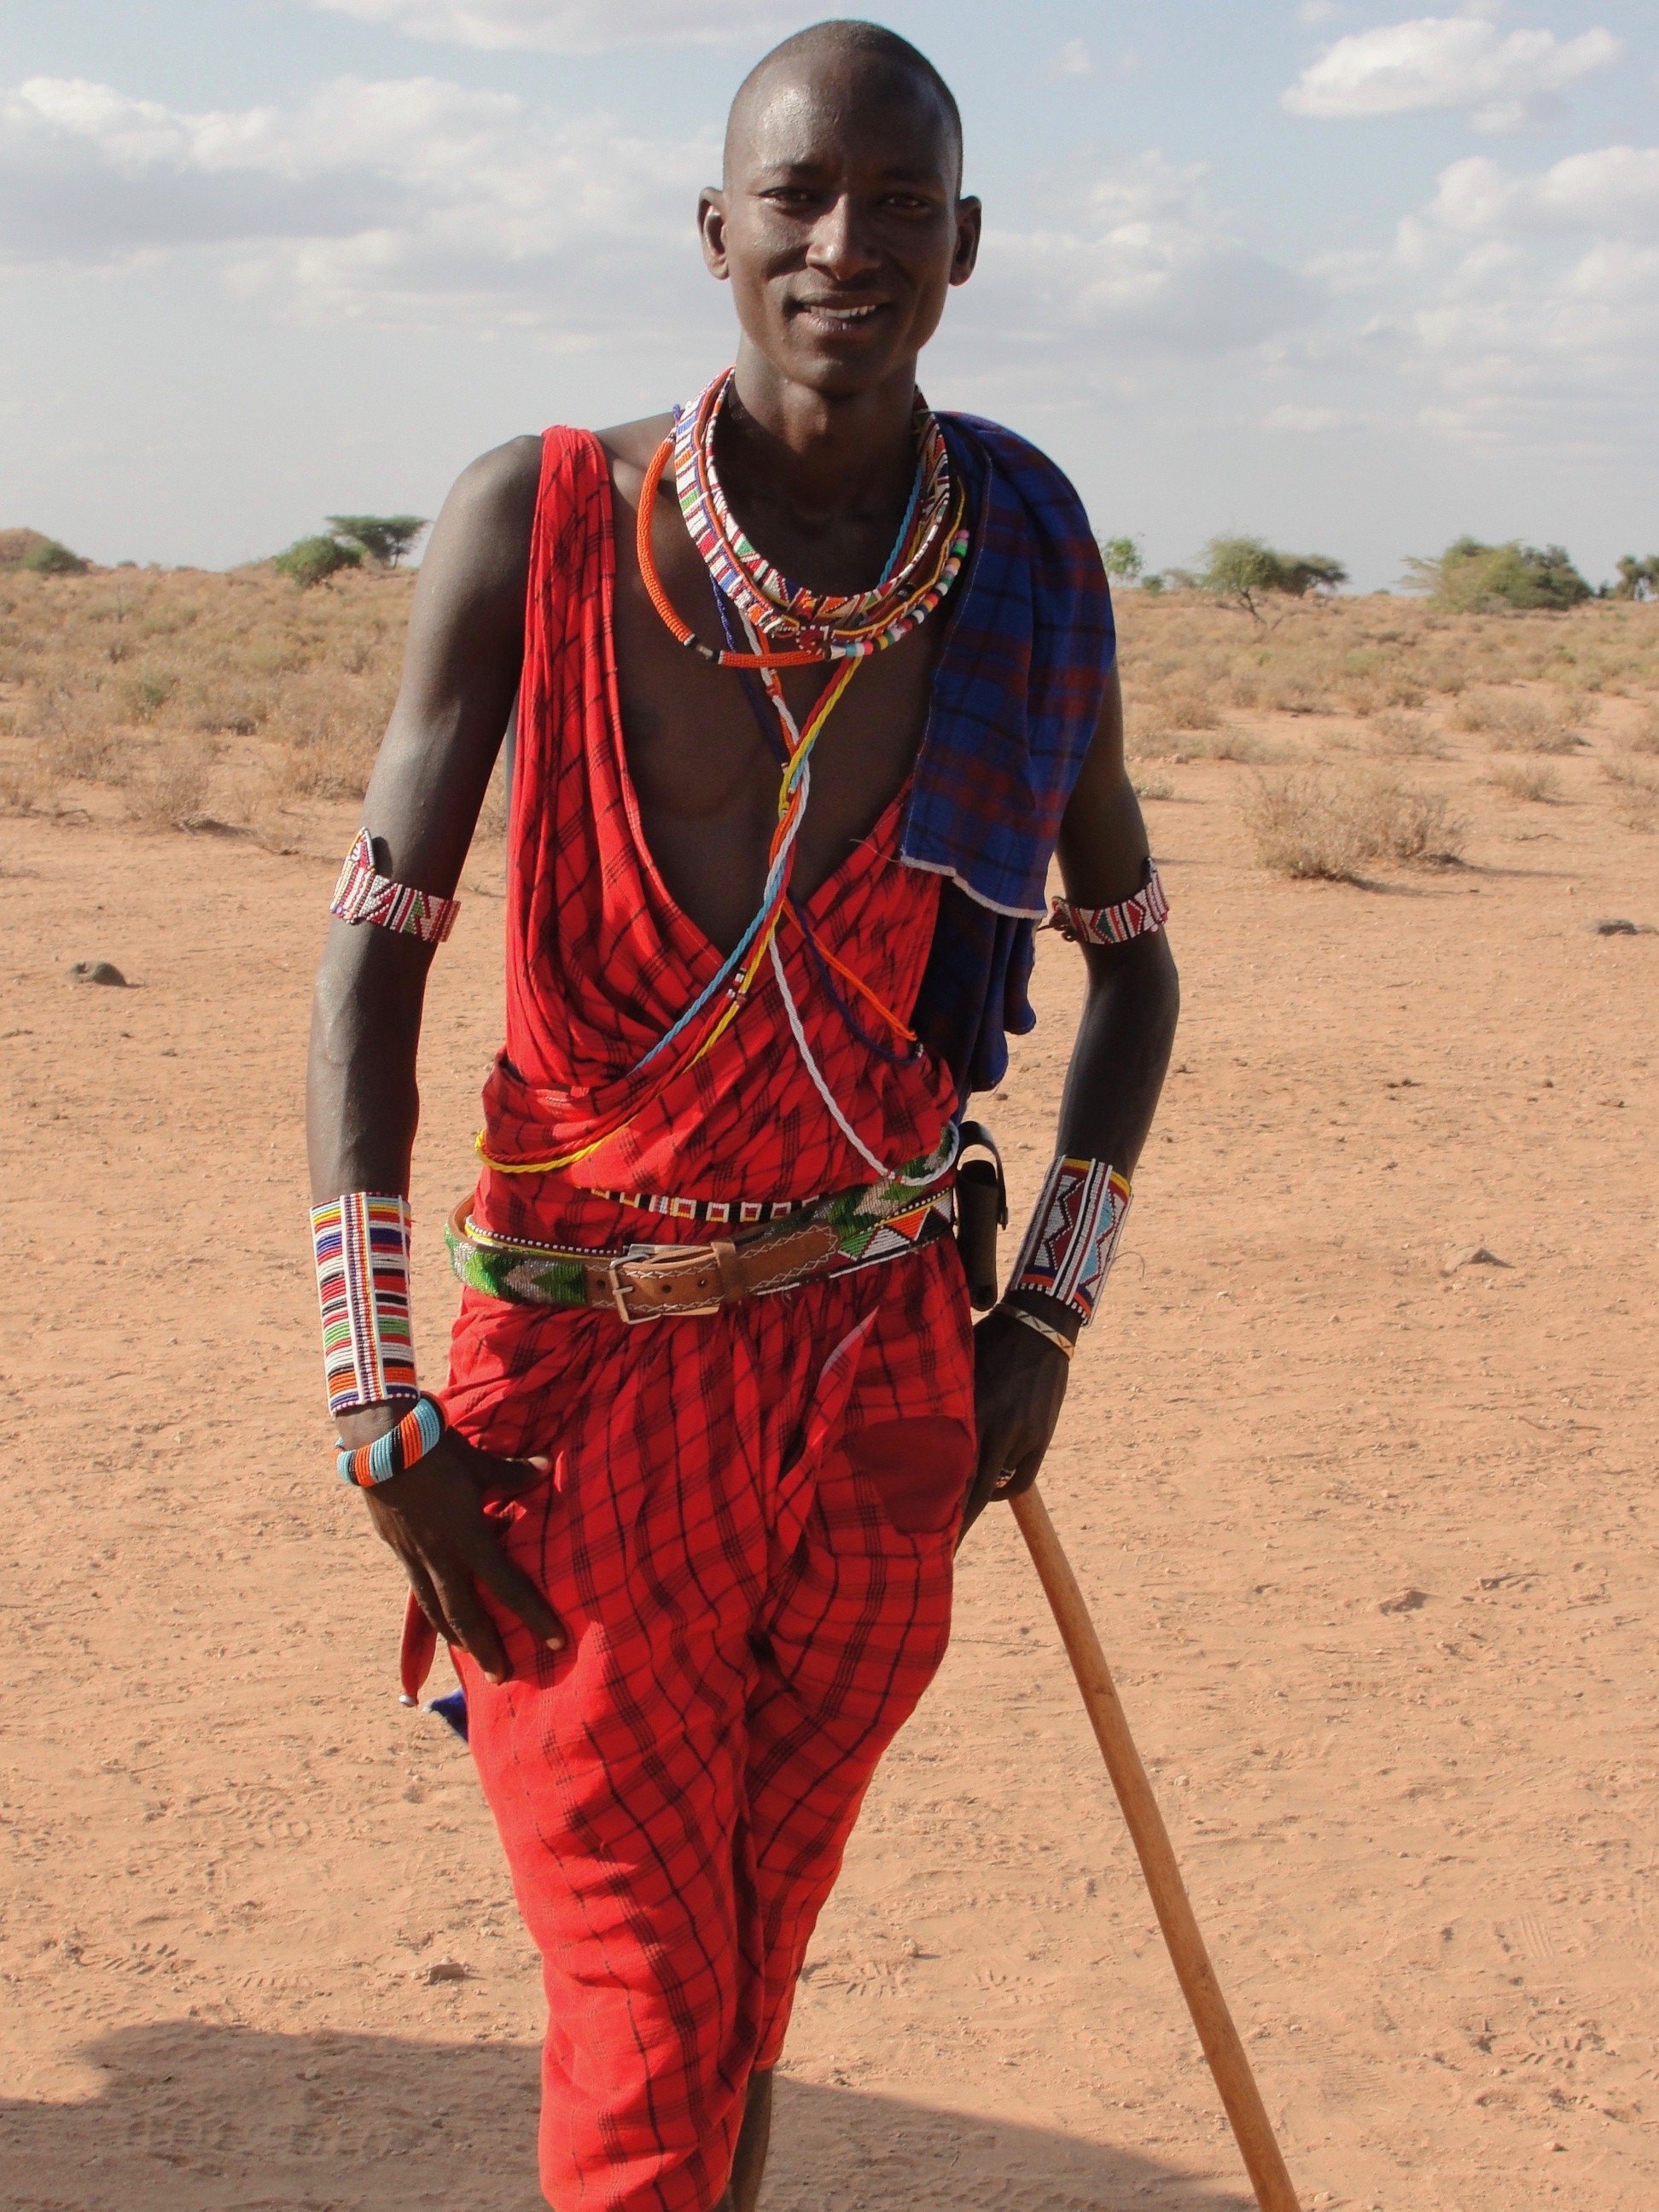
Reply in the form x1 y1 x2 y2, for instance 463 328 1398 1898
363 1429 567 1684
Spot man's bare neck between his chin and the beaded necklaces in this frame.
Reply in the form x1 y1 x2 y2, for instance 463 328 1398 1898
719 339 916 522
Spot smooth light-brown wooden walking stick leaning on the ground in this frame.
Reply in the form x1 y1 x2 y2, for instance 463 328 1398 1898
1011 1488 1301 2212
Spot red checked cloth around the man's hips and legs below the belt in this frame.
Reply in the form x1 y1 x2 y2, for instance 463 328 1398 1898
445 1239 973 2212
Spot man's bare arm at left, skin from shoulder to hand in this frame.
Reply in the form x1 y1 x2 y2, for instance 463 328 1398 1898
306 438 562 1679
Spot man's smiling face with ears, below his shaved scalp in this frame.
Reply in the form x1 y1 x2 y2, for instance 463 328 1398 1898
701 49 980 399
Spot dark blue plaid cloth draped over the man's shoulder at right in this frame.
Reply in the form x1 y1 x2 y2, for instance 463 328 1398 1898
898 414 1117 1102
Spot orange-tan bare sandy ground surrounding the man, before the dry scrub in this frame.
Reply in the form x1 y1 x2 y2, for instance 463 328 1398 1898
0 741 1659 2212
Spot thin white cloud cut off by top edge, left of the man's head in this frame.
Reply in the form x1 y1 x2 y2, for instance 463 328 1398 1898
311 0 812 53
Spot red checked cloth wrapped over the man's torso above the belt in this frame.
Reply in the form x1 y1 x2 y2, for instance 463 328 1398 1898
474 429 956 1245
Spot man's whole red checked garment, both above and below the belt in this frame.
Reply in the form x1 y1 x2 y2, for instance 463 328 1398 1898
445 431 973 2212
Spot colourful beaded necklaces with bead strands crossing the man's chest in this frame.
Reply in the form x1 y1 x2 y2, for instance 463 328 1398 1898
478 370 969 1174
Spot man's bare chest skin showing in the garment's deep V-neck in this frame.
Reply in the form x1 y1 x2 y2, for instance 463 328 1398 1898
613 471 942 952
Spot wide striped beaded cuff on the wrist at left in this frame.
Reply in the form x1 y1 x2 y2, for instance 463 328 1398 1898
311 1190 420 1413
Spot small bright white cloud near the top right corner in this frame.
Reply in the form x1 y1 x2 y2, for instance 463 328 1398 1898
1283 15 1624 131
